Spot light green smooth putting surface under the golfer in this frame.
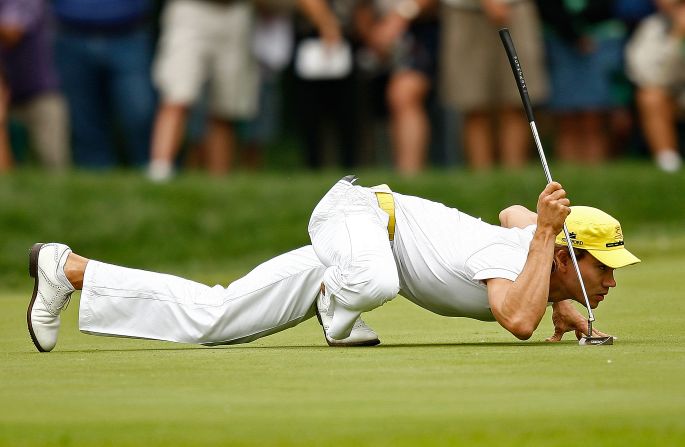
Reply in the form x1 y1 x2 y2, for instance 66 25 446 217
0 250 685 446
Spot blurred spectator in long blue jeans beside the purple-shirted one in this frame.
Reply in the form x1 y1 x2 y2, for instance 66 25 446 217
53 0 155 168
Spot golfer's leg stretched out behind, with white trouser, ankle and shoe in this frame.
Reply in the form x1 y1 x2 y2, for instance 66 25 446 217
27 243 377 352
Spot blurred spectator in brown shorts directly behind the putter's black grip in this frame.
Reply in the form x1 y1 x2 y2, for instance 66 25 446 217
440 0 547 169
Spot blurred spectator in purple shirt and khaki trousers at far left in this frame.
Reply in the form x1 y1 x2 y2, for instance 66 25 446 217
0 0 70 170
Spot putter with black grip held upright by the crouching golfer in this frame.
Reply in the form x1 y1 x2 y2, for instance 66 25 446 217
499 28 614 346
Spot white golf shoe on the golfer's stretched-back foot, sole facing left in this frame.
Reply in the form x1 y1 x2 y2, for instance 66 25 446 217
26 244 74 352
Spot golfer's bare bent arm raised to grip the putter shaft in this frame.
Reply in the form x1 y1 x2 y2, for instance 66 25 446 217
487 182 570 340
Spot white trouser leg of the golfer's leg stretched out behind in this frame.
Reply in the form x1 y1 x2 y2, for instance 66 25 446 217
79 246 326 345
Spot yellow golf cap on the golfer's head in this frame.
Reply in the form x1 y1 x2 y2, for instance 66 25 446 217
555 206 640 268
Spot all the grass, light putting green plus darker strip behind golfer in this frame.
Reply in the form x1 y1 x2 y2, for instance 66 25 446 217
0 165 685 446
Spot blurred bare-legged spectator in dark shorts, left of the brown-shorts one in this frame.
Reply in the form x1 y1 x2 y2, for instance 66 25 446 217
355 0 439 175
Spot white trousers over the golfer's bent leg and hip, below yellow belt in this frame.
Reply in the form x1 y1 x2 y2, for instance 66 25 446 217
309 177 400 340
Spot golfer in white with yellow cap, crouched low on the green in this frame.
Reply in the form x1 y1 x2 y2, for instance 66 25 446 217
27 176 640 351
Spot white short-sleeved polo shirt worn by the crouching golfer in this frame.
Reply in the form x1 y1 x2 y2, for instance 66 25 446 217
393 193 535 321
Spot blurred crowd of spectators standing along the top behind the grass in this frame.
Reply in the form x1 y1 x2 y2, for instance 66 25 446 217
0 0 685 181
